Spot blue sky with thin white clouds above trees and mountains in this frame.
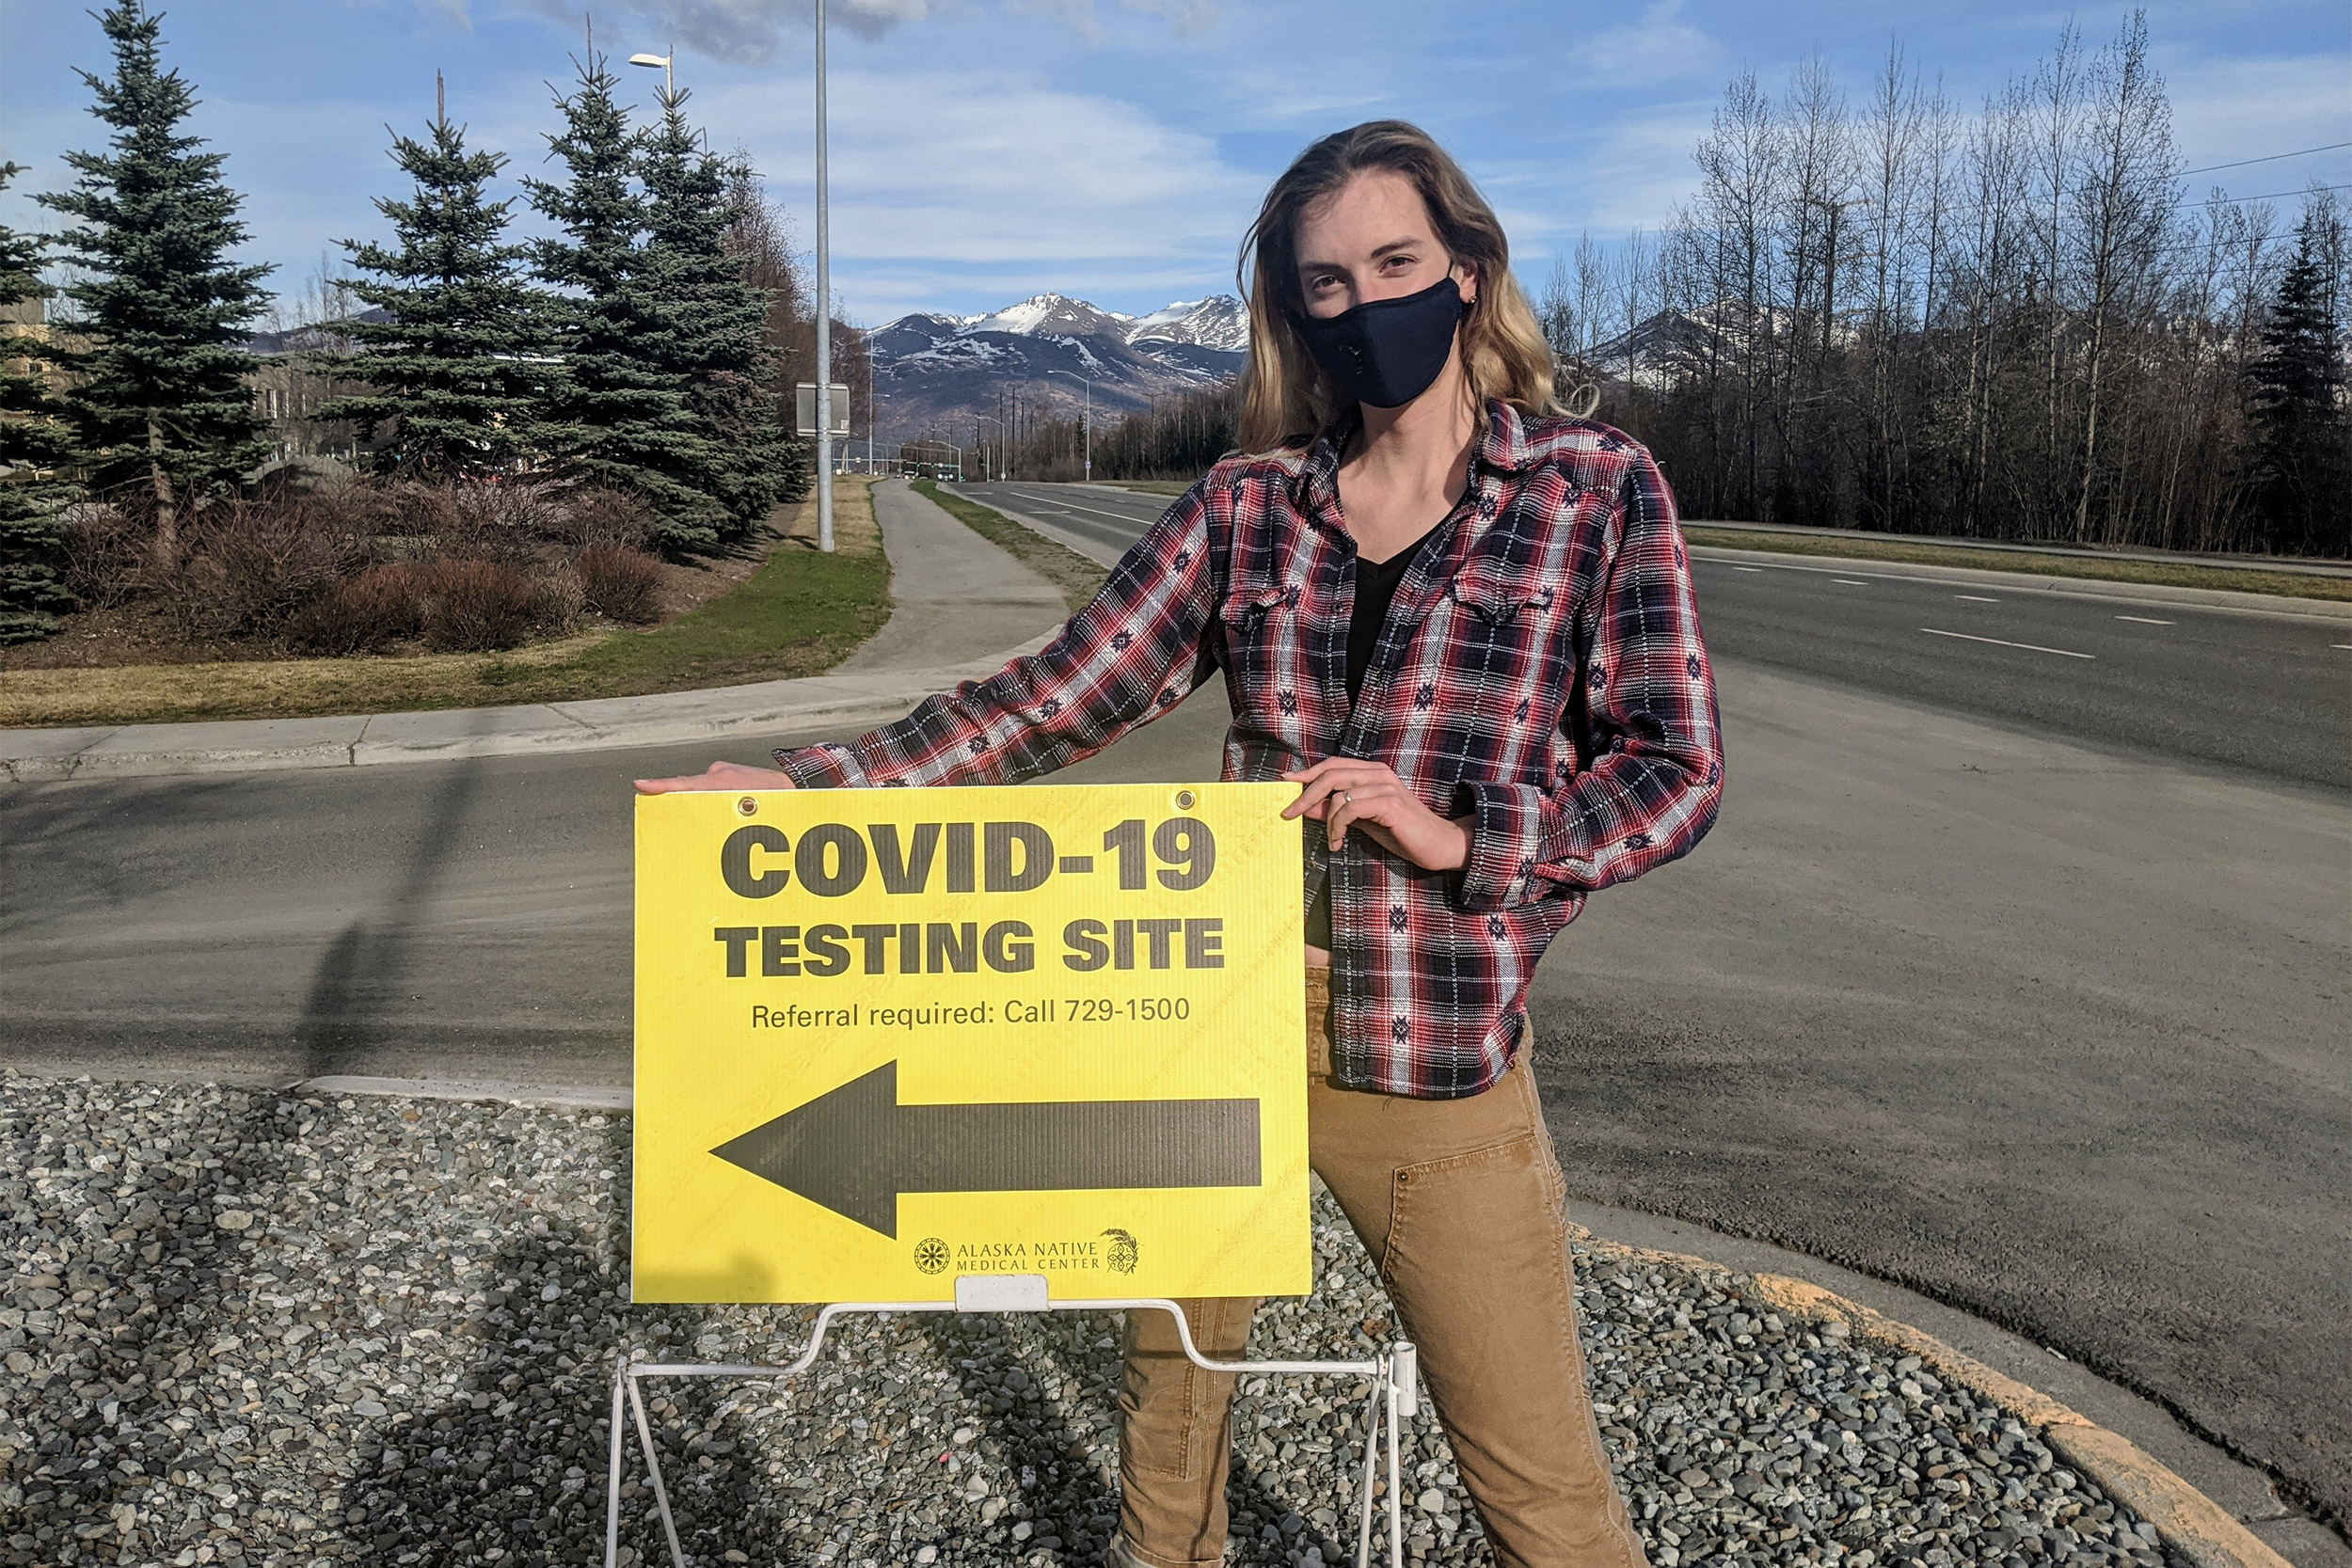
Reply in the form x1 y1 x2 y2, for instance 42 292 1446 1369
0 0 2352 322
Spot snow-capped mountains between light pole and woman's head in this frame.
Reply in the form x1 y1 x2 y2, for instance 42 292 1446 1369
868 293 1249 439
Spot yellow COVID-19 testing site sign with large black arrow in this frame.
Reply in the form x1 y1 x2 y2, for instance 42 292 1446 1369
633 783 1312 1303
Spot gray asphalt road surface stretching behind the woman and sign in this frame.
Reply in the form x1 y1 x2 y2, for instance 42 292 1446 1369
0 494 2352 1526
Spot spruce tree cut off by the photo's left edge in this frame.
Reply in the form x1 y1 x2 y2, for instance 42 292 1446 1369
0 162 75 644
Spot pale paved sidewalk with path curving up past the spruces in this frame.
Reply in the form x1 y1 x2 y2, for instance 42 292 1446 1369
0 482 1066 783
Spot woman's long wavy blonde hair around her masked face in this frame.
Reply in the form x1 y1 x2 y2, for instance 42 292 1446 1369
1235 119 1562 451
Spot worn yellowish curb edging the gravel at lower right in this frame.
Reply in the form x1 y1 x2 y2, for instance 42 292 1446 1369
1574 1225 2291 1568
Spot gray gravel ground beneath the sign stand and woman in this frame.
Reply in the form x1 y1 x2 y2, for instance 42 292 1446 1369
0 1072 2167 1568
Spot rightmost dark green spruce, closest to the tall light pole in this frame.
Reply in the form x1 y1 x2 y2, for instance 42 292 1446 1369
643 89 809 538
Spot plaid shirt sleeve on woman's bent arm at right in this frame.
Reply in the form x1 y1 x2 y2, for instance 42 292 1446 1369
1454 451 1724 912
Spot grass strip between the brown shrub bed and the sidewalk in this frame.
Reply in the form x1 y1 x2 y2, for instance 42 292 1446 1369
0 480 889 726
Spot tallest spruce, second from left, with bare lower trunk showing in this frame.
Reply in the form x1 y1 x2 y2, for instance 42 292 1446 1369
40 0 271 564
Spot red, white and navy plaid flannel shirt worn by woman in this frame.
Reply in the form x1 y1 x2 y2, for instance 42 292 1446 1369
776 402 1724 1098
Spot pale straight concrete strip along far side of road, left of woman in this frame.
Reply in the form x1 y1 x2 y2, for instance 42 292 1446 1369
0 635 1049 785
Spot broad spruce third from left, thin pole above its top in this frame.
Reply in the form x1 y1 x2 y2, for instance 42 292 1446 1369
318 80 546 482
